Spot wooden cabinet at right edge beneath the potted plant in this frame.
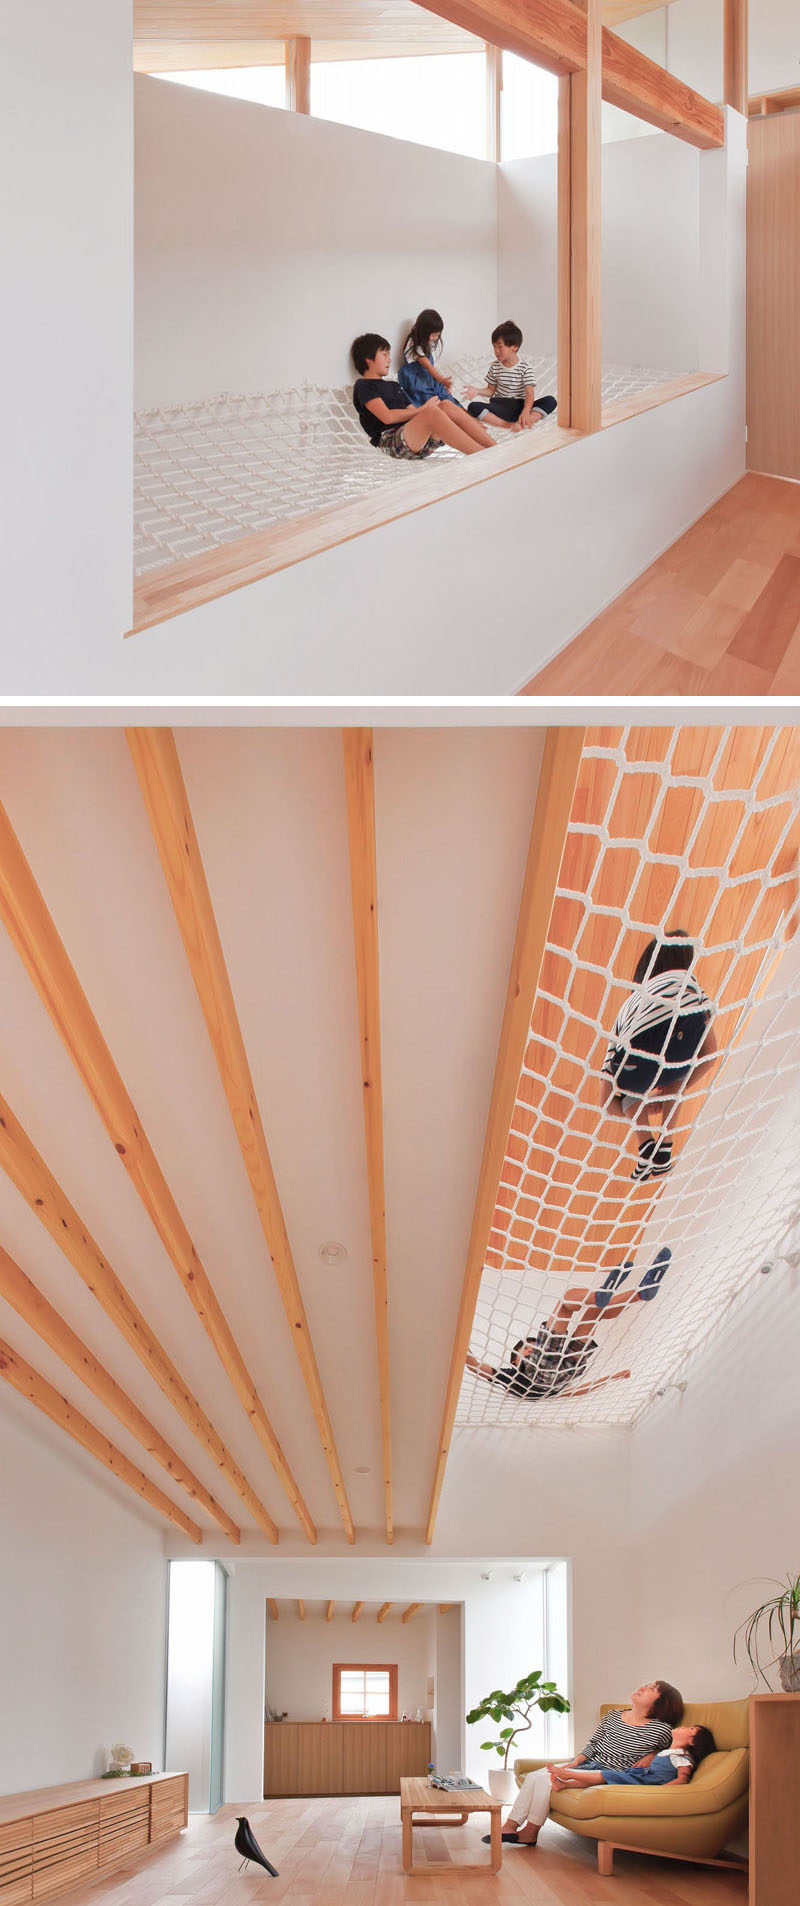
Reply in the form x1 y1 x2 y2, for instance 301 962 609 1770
750 1694 800 1906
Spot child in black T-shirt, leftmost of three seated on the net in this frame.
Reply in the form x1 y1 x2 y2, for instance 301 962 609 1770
350 332 495 461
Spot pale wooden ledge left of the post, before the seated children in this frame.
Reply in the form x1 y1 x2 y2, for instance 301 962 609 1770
128 425 581 635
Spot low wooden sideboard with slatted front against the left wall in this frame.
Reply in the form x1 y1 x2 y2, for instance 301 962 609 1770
0 1774 189 1906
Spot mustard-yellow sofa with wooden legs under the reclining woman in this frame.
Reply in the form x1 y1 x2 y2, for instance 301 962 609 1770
514 1700 750 1874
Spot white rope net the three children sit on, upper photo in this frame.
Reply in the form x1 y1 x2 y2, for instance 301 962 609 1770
133 356 672 576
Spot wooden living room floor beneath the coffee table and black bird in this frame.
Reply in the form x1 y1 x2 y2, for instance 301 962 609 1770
67 1795 747 1906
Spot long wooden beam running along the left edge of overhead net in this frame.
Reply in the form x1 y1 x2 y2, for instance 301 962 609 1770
425 728 583 1542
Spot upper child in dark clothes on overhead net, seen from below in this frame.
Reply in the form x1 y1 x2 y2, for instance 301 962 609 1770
600 926 716 1180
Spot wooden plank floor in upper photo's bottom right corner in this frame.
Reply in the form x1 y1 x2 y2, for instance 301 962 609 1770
524 475 800 698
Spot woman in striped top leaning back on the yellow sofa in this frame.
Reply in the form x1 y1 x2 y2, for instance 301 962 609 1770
491 1681 684 1847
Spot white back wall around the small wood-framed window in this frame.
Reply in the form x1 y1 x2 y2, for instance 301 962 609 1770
267 1603 434 1721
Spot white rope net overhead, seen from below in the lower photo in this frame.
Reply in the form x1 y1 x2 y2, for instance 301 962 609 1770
457 728 800 1428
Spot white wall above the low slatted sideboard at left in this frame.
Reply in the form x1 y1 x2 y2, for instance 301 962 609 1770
0 1386 168 1794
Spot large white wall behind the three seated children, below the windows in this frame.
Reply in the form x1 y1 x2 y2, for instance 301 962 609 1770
135 76 497 408
